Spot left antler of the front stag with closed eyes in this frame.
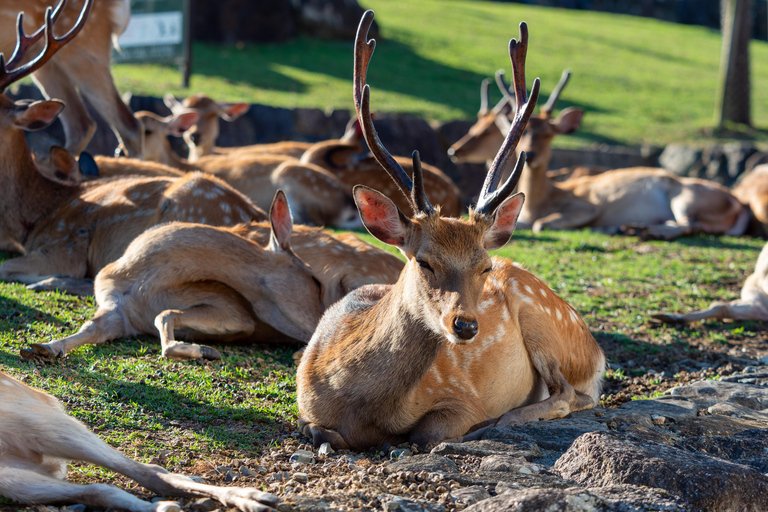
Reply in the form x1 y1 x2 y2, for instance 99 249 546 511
352 10 435 215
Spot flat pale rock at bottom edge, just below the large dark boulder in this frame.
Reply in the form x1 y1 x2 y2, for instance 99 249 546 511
464 486 692 512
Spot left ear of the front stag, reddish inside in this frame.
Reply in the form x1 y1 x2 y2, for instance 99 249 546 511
353 185 410 249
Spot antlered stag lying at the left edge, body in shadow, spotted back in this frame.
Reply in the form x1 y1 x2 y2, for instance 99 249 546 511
0 9 267 294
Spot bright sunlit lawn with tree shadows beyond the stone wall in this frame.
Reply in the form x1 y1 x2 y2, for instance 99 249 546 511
109 0 768 147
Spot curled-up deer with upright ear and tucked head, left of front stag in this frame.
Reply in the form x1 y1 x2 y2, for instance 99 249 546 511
23 191 402 359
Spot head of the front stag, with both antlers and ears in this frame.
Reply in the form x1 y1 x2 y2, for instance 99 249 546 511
353 11 539 344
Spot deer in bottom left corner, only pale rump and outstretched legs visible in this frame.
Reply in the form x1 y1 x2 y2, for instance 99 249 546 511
0 372 280 512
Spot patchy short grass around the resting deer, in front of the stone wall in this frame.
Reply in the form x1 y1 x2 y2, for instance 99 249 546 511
0 231 764 460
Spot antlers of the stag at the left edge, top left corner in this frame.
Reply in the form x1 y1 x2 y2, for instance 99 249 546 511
0 0 94 91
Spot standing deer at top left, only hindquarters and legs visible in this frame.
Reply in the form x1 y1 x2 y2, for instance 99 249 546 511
0 0 142 156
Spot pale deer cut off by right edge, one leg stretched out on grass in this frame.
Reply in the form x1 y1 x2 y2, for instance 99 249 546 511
651 244 768 324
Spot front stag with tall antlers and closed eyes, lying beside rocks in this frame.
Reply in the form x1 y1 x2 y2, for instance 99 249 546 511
296 11 605 449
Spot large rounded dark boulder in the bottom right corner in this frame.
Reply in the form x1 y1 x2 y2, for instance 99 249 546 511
554 432 768 512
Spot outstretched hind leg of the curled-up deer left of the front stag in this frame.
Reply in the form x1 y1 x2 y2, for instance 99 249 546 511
21 309 127 357
